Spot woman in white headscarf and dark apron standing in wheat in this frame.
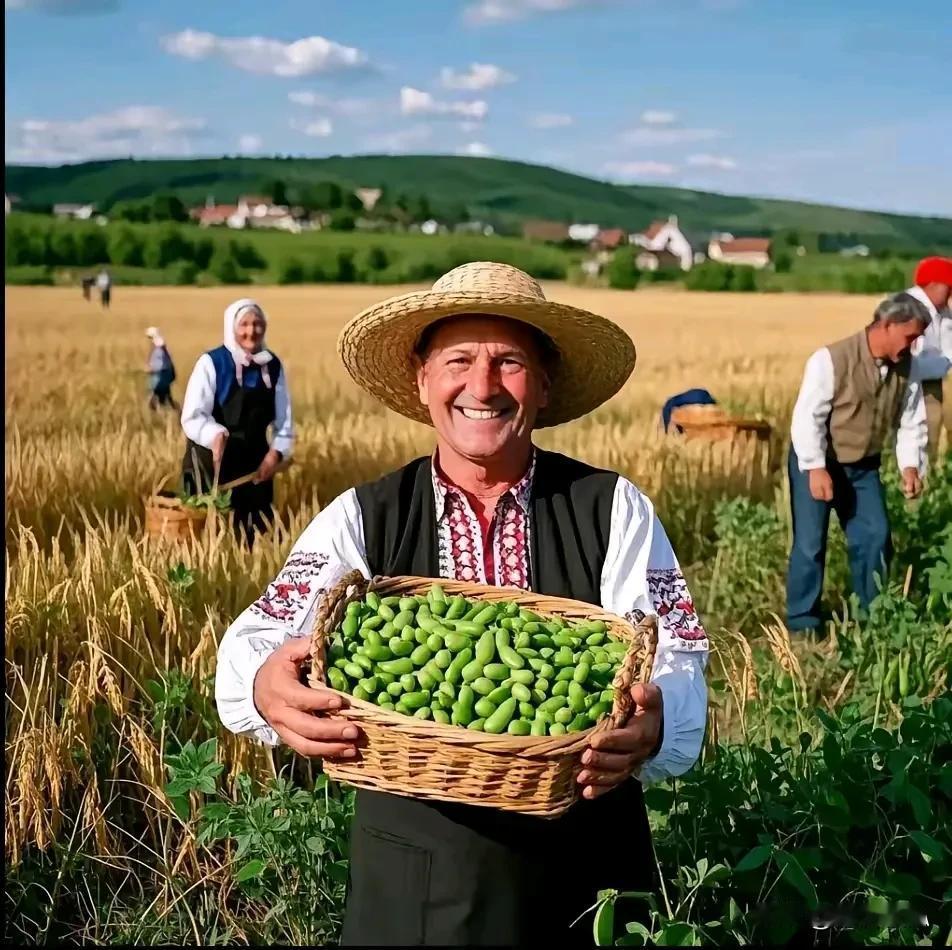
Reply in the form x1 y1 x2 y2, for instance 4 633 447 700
182 298 294 544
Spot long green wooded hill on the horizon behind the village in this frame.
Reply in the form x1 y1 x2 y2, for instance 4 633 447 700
5 155 952 248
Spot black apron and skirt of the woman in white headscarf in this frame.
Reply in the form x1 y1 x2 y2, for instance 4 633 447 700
182 348 280 543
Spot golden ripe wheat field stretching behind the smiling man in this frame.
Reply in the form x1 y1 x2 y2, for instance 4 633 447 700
5 285 888 916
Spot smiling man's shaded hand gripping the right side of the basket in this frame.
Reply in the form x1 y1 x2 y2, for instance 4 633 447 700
578 683 664 798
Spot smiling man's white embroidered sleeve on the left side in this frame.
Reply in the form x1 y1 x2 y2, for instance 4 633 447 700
215 489 370 745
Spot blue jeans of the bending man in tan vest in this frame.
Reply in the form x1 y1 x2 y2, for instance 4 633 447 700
787 448 892 630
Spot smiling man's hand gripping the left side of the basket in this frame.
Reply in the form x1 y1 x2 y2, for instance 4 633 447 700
254 637 360 759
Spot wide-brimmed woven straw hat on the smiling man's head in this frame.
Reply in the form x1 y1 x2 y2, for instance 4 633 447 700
337 261 635 428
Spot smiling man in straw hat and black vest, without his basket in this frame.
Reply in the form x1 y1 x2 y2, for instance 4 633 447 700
216 263 708 946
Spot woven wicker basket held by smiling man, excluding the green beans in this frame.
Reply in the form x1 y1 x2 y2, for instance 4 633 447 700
308 571 658 818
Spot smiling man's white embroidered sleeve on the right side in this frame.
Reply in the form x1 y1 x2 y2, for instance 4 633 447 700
601 477 710 783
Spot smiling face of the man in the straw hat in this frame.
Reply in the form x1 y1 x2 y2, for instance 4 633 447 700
417 316 549 461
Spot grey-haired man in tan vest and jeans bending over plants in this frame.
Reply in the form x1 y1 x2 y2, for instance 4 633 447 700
787 293 930 631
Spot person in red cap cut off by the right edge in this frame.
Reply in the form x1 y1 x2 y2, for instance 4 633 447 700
906 257 952 461
